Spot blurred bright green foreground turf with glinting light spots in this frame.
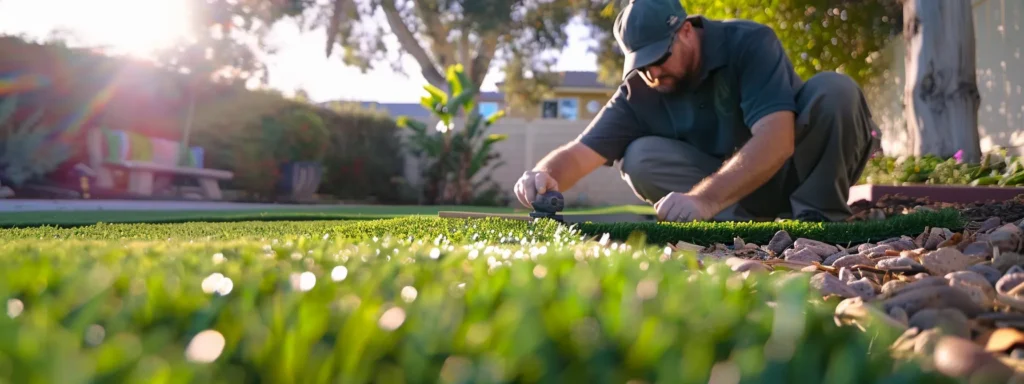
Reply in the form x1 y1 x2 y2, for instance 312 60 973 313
0 224 950 383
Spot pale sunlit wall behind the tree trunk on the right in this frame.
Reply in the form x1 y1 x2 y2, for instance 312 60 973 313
864 0 1024 156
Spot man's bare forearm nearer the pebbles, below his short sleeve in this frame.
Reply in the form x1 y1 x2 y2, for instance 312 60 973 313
690 113 794 212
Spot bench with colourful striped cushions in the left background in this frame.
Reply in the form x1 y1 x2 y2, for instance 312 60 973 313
87 128 234 200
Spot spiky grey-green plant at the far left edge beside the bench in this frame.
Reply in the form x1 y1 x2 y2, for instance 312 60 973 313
0 94 74 187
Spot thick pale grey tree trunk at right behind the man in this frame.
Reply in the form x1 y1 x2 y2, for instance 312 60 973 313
903 0 981 162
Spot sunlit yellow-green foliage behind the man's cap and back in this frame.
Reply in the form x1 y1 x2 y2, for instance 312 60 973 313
586 0 903 85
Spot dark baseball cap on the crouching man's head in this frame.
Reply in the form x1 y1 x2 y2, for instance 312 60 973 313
612 0 686 80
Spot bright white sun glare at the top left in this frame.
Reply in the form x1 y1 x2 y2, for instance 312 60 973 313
69 0 189 57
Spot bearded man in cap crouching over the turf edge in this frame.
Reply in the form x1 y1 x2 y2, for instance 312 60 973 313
515 0 879 221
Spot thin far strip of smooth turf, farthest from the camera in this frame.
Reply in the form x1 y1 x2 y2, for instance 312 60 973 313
0 205 653 228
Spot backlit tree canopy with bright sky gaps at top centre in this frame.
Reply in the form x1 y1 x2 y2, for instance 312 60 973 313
299 0 583 112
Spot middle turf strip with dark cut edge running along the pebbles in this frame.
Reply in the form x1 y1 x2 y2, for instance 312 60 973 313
0 210 964 245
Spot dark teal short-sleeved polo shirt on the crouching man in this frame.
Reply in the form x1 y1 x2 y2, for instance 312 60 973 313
579 16 803 166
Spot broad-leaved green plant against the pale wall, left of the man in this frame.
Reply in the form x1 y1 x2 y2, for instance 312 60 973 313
398 66 508 204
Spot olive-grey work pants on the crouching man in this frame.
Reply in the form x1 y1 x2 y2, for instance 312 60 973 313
620 72 880 221
